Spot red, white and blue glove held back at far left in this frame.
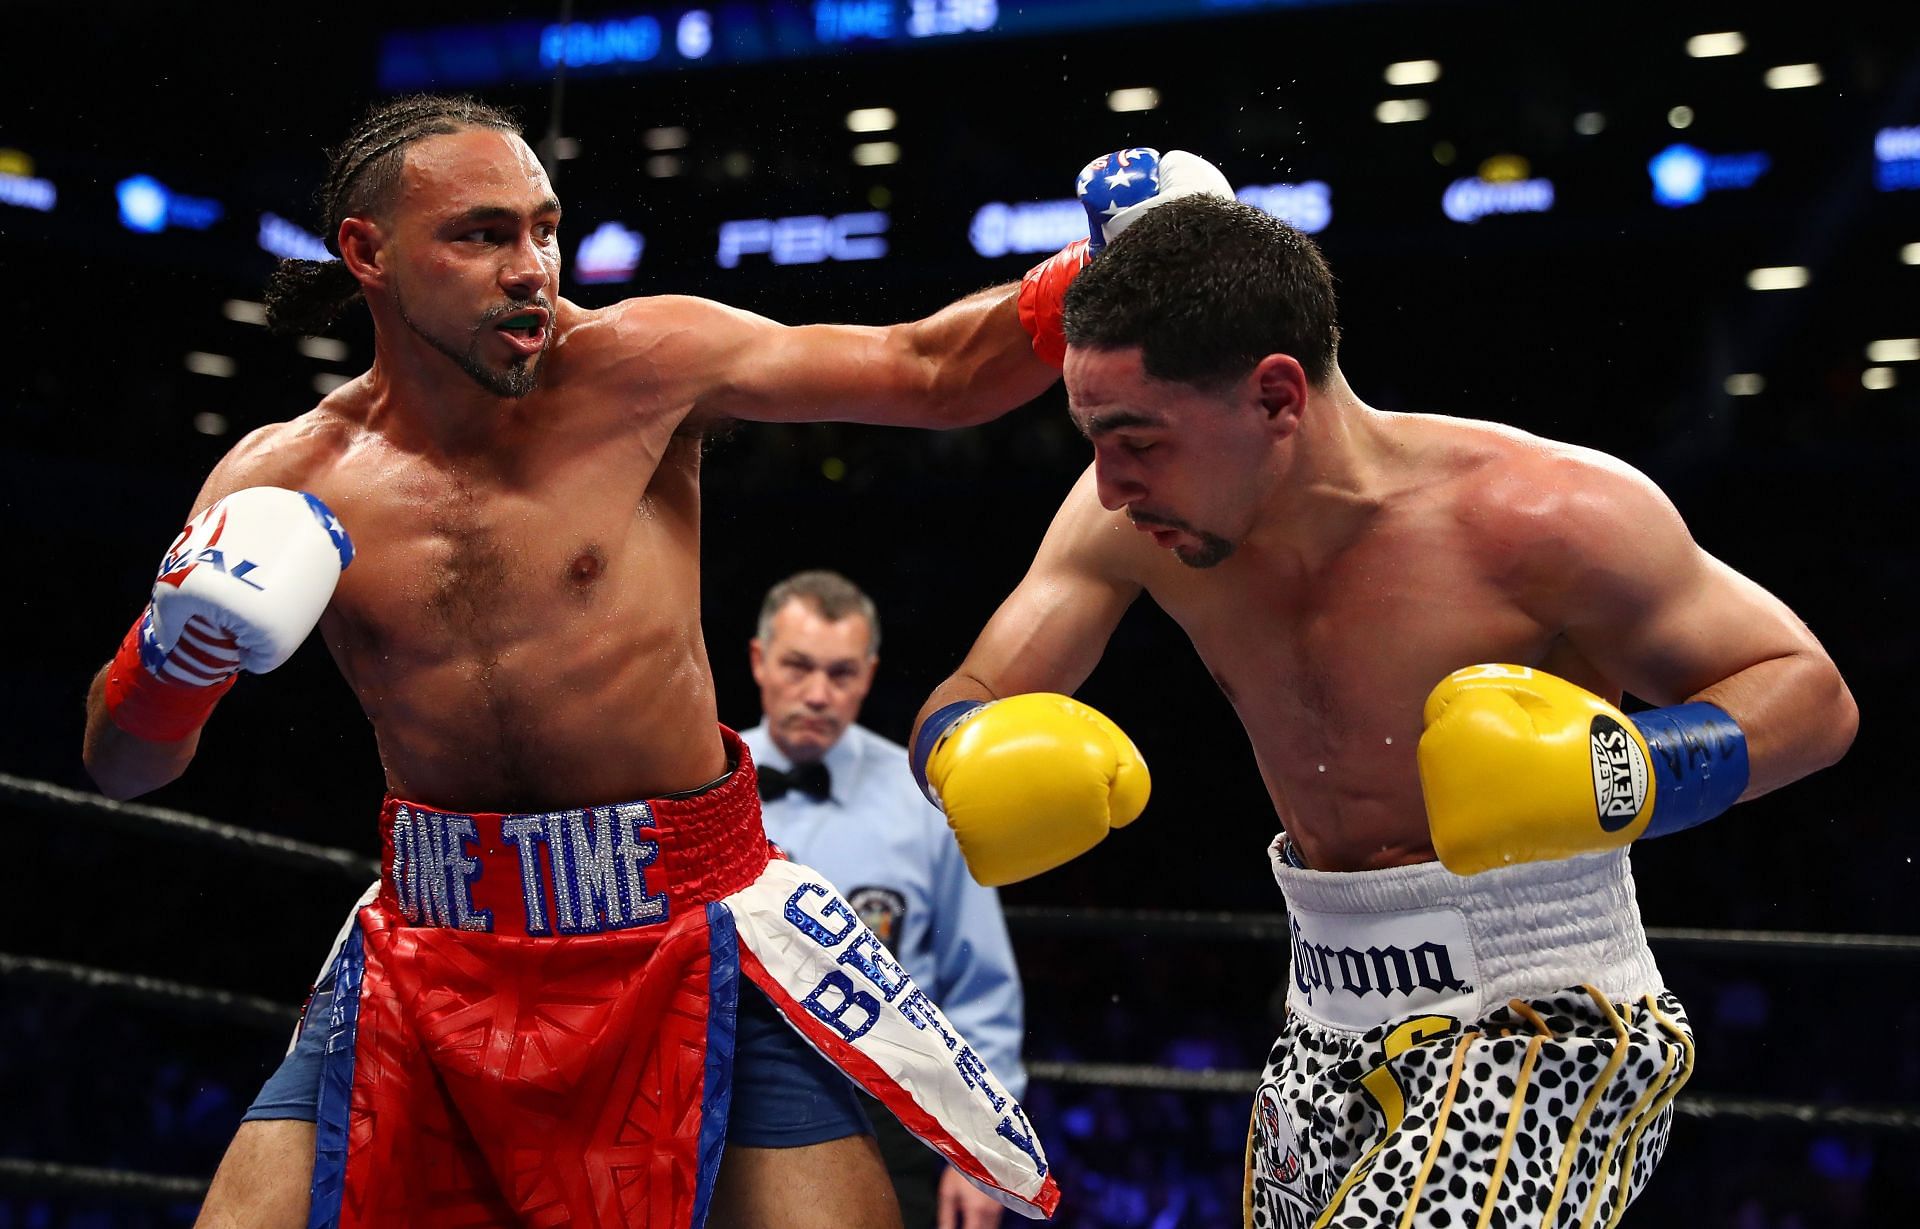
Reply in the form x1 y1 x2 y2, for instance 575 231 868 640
106 486 353 743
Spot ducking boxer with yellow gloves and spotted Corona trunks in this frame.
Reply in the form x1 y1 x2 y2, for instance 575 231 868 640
914 196 1857 1229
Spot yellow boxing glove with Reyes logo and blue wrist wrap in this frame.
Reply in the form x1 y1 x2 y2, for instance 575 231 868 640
1419 664 1747 876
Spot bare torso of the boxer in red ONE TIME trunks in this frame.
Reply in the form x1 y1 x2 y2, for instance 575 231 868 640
234 309 724 810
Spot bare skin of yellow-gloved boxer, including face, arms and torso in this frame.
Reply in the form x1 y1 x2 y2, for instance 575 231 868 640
922 348 1855 870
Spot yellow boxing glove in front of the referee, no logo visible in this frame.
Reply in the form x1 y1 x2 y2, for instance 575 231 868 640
914 691 1150 887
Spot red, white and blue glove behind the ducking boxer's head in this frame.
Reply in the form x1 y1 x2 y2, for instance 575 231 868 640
1020 146 1233 367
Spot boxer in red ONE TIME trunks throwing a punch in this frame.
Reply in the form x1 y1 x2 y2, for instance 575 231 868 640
84 98 1228 1229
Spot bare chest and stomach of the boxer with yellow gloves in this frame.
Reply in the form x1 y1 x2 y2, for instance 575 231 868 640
1154 489 1592 868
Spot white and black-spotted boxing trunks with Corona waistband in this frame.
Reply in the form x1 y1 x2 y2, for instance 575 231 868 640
1246 837 1693 1229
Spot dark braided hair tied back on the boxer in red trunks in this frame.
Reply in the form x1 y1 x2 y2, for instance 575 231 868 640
267 94 520 334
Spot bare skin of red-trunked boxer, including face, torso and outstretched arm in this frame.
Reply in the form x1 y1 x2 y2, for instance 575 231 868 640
90 131 1052 810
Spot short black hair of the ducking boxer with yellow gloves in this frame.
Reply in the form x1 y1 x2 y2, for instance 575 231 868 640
1066 196 1340 386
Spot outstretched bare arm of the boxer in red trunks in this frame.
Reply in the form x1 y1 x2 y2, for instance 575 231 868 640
689 284 1060 437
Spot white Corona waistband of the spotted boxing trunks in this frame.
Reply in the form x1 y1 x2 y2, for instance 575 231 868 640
1269 837 1665 1031
